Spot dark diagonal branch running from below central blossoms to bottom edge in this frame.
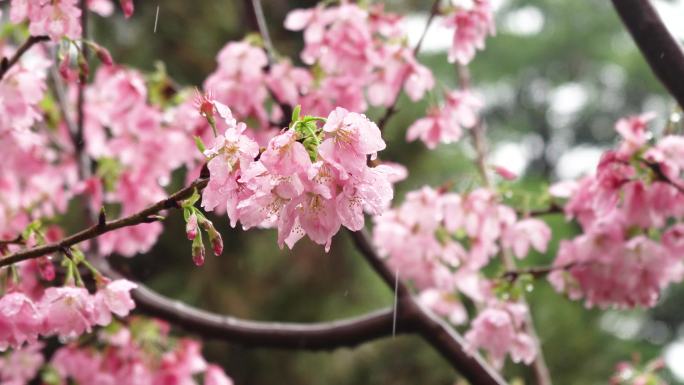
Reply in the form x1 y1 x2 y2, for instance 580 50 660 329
351 231 506 385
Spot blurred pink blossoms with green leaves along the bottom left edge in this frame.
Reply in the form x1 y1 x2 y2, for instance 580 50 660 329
0 318 233 385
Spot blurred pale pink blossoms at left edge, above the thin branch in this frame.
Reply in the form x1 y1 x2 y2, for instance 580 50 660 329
0 48 76 240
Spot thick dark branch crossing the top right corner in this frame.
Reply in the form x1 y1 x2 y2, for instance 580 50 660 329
612 0 684 107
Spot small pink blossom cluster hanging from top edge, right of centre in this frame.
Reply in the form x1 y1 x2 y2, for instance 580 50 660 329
444 0 496 65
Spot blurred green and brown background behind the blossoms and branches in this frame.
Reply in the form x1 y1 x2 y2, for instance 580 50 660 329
93 0 684 385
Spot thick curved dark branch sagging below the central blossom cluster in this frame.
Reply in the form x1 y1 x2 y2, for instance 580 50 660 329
98 261 413 350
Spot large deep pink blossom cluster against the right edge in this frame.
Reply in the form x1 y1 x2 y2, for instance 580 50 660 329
549 115 684 307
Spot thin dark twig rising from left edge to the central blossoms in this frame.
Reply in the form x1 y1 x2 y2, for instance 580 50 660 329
0 179 209 267
